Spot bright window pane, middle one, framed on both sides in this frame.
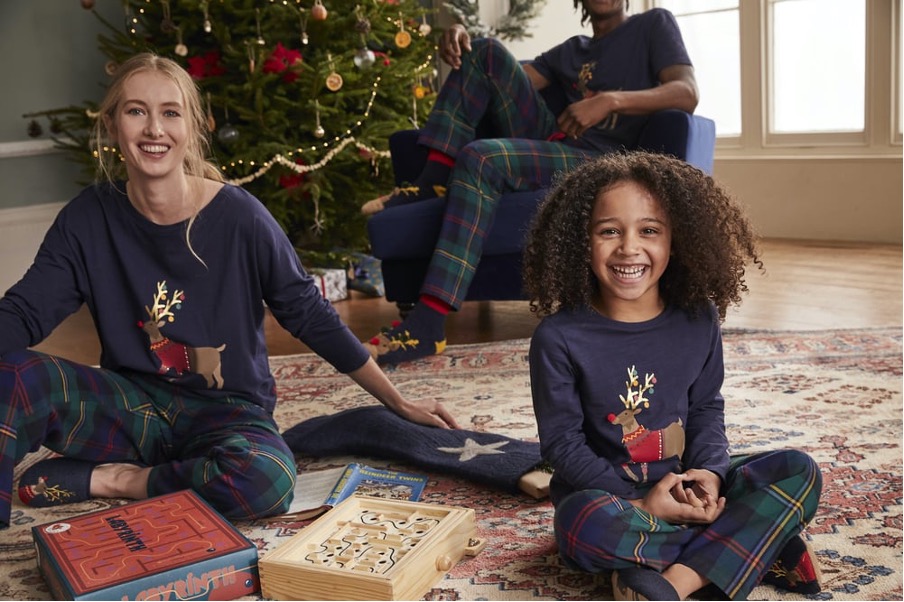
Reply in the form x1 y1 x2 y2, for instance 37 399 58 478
770 0 866 133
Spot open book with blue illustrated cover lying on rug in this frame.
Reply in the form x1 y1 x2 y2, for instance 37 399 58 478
284 463 427 520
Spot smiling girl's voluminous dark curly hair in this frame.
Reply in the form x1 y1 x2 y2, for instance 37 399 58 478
524 151 763 320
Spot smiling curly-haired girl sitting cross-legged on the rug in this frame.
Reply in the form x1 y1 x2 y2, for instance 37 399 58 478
524 152 822 600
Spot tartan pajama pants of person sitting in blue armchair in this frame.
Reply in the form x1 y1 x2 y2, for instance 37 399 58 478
418 39 600 309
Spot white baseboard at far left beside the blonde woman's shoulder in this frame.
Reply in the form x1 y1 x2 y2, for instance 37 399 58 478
0 202 66 292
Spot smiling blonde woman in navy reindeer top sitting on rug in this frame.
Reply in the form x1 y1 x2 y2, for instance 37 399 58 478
0 54 456 526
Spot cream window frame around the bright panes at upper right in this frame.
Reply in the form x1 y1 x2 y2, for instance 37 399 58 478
648 0 902 157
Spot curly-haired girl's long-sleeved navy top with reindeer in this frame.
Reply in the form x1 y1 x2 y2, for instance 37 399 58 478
530 308 728 503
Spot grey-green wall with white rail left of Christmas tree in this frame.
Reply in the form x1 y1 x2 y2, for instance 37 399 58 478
0 0 124 209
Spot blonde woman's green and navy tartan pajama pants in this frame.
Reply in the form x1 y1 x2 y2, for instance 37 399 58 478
0 351 296 527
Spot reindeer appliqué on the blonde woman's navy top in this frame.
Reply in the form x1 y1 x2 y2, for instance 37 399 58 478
138 280 226 389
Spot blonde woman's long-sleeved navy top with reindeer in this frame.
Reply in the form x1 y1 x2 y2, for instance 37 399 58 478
0 182 368 411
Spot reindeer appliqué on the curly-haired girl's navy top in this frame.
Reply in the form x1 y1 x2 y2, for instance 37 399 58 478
608 366 684 482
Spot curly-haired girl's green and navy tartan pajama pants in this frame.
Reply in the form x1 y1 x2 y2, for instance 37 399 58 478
555 450 822 600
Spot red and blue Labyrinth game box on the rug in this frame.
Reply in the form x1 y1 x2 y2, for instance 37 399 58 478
32 490 260 600
